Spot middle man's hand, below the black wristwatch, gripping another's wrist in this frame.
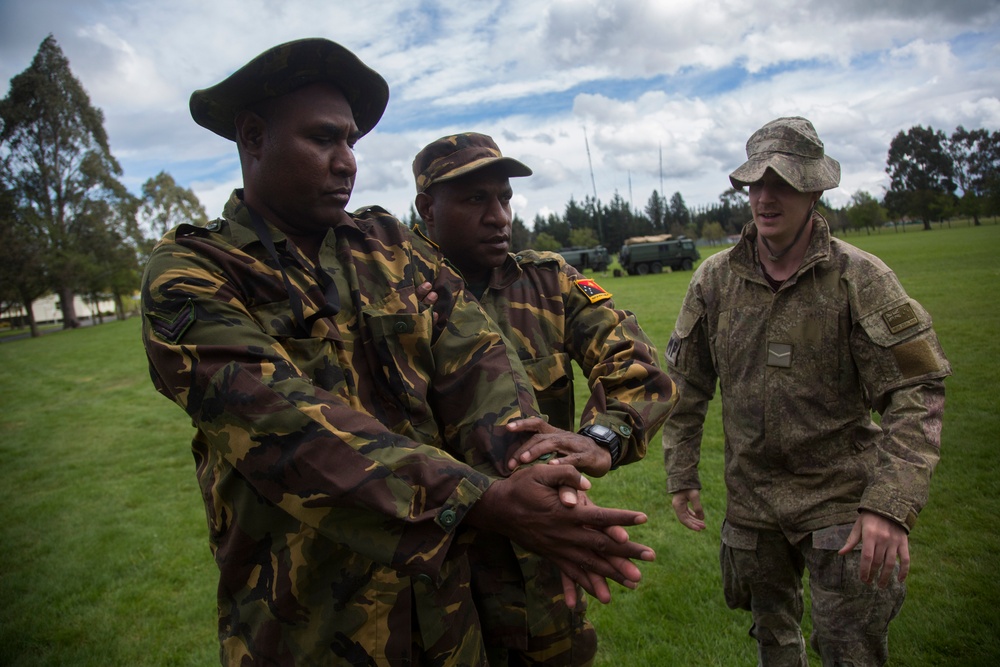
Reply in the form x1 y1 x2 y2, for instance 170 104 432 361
507 417 611 477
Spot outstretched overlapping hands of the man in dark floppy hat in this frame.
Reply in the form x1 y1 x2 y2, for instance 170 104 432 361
467 465 656 604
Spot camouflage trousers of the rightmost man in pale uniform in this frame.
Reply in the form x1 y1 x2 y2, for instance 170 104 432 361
720 522 906 667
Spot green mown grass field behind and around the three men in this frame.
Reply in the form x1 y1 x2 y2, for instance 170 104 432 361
0 224 1000 667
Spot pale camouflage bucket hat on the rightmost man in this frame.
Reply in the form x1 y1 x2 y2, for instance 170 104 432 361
729 116 840 192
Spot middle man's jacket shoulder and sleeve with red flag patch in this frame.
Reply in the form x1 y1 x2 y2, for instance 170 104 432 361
480 250 677 463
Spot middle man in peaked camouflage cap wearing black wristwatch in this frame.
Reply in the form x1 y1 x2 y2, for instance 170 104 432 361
413 133 676 665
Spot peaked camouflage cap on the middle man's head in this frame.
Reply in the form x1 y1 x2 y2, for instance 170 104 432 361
413 132 531 192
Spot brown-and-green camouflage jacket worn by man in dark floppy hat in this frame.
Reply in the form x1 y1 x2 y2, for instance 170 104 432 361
142 191 538 665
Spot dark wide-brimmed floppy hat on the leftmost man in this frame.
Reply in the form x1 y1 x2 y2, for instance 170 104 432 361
190 38 389 141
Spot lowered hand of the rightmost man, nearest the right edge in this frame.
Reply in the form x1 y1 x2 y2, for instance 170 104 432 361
838 510 910 588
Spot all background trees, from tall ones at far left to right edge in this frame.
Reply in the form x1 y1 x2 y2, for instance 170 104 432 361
0 35 1000 336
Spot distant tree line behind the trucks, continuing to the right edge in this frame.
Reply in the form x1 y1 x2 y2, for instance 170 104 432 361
408 125 1000 252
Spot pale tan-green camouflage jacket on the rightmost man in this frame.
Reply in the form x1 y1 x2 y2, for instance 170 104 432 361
663 215 951 542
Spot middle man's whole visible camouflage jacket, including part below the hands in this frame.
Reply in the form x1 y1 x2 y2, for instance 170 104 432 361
456 250 676 664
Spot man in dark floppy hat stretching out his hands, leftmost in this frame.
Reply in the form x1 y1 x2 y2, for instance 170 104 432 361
142 39 652 665
